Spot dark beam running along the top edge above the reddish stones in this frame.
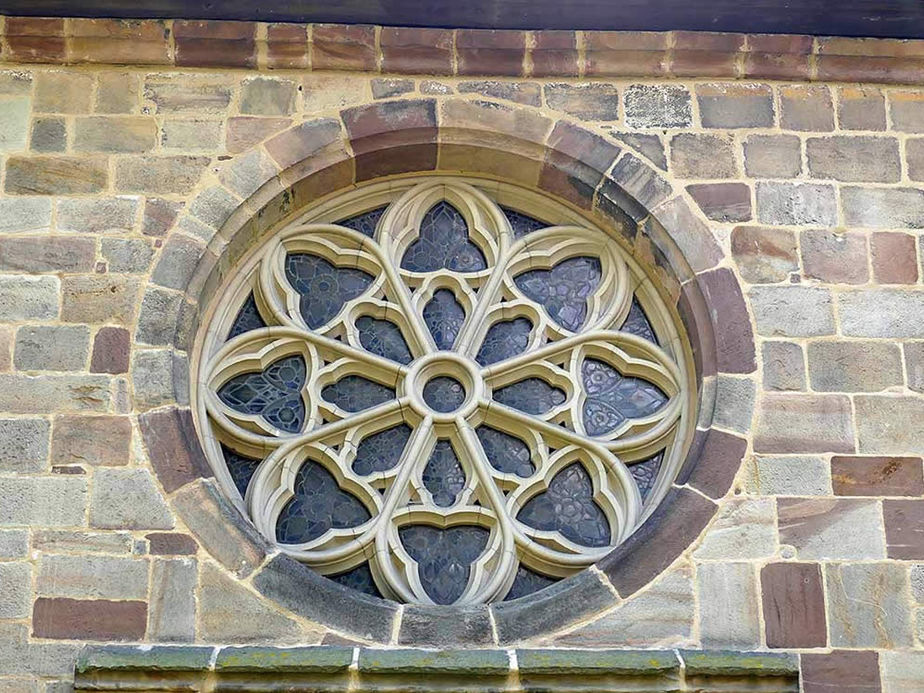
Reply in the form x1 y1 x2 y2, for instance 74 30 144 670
0 0 924 38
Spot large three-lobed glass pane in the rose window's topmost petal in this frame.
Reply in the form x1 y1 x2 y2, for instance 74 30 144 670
401 200 488 272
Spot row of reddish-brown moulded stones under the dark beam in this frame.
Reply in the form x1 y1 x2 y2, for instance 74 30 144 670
0 17 924 85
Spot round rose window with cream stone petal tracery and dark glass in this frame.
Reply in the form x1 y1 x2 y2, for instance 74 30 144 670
194 177 695 604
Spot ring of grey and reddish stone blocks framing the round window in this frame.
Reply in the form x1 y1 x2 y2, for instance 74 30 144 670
136 98 756 645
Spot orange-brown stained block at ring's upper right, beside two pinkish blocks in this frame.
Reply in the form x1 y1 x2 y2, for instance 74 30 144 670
731 226 799 284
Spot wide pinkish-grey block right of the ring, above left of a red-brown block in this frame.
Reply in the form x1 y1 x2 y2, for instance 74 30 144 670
754 393 854 454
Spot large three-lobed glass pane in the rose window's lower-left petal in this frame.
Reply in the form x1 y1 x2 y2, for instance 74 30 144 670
276 460 371 544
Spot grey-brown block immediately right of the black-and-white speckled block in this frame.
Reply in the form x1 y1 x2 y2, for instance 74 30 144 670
696 84 774 128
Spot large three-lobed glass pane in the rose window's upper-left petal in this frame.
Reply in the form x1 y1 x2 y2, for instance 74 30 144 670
286 253 374 328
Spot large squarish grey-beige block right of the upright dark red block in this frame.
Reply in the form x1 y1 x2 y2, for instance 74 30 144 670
825 563 911 649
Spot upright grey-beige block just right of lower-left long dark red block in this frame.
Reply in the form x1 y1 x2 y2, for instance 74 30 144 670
147 558 198 642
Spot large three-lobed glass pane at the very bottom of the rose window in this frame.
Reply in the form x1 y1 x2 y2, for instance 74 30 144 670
398 525 490 604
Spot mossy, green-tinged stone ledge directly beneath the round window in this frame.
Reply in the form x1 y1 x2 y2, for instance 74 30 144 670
75 645 799 693
